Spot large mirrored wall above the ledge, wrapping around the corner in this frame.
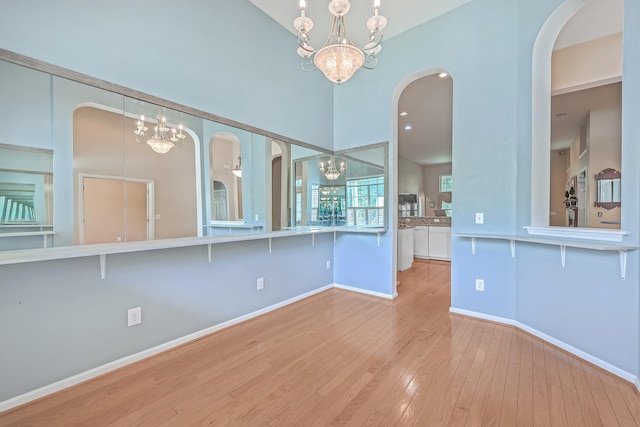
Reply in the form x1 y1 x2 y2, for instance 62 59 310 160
0 51 388 251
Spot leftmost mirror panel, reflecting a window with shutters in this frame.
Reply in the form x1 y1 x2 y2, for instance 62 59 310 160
0 61 53 251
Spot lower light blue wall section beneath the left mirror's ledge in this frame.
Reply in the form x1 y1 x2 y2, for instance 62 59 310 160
0 234 333 402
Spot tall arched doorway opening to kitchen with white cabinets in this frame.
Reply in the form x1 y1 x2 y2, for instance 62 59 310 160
393 68 453 294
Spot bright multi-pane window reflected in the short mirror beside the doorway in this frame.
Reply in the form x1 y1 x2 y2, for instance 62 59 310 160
346 176 384 226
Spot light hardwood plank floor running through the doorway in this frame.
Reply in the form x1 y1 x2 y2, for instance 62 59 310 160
0 261 640 427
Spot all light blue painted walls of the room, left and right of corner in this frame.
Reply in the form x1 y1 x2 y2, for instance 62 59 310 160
0 0 640 401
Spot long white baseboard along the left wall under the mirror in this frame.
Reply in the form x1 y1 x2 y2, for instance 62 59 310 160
0 284 334 412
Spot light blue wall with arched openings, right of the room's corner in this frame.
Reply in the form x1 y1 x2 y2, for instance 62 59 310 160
334 0 640 378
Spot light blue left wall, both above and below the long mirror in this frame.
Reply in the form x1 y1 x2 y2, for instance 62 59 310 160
0 0 333 402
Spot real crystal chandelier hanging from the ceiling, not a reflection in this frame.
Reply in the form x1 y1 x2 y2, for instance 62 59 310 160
293 0 387 84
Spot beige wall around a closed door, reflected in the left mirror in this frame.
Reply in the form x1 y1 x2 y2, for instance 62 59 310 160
73 107 198 244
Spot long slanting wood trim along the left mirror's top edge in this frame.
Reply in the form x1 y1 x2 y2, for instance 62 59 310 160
0 48 333 154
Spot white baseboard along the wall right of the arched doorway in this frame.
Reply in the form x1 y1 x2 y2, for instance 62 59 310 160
449 307 640 391
